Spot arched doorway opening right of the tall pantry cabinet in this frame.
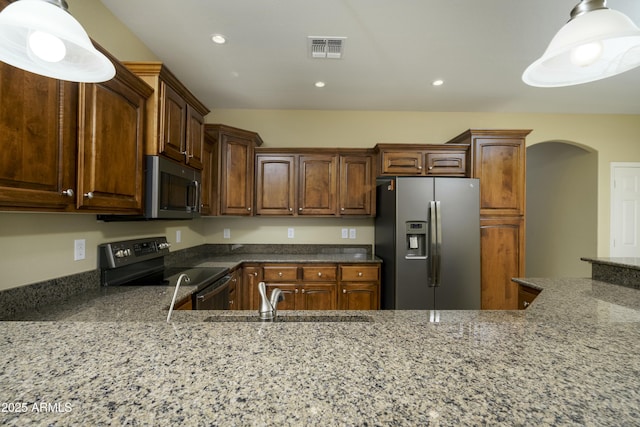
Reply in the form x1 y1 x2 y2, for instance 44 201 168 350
526 141 598 277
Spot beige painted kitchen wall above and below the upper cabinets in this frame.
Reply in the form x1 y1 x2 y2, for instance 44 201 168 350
0 0 640 290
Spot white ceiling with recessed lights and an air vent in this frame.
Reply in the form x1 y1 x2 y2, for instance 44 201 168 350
101 0 640 114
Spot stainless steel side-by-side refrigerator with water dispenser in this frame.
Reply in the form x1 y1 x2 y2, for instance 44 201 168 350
375 177 480 310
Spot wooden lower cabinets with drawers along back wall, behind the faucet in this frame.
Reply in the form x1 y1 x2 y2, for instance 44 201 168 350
238 263 380 310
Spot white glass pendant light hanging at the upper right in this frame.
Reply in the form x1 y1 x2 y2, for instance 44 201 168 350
522 0 640 87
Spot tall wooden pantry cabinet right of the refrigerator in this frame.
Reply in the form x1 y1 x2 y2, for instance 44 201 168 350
450 129 531 310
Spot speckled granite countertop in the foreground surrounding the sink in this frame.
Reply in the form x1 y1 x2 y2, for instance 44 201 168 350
0 278 640 426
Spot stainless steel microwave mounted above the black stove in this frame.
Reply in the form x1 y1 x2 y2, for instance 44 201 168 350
144 156 202 219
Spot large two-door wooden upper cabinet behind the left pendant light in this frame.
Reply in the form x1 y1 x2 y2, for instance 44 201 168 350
0 34 152 213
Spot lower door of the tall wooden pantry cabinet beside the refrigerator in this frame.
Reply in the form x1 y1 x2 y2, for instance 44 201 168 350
480 217 524 310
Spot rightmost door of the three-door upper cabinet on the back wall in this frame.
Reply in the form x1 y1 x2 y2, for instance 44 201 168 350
340 155 375 215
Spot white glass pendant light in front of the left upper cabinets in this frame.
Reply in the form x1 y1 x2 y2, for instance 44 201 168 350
0 0 116 83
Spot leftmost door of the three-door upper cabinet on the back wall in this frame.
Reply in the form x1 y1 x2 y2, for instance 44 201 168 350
256 154 296 215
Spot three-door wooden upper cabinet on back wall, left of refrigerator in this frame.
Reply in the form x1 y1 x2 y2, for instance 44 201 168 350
256 149 375 216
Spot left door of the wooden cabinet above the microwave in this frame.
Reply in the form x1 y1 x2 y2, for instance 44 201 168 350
158 82 187 162
